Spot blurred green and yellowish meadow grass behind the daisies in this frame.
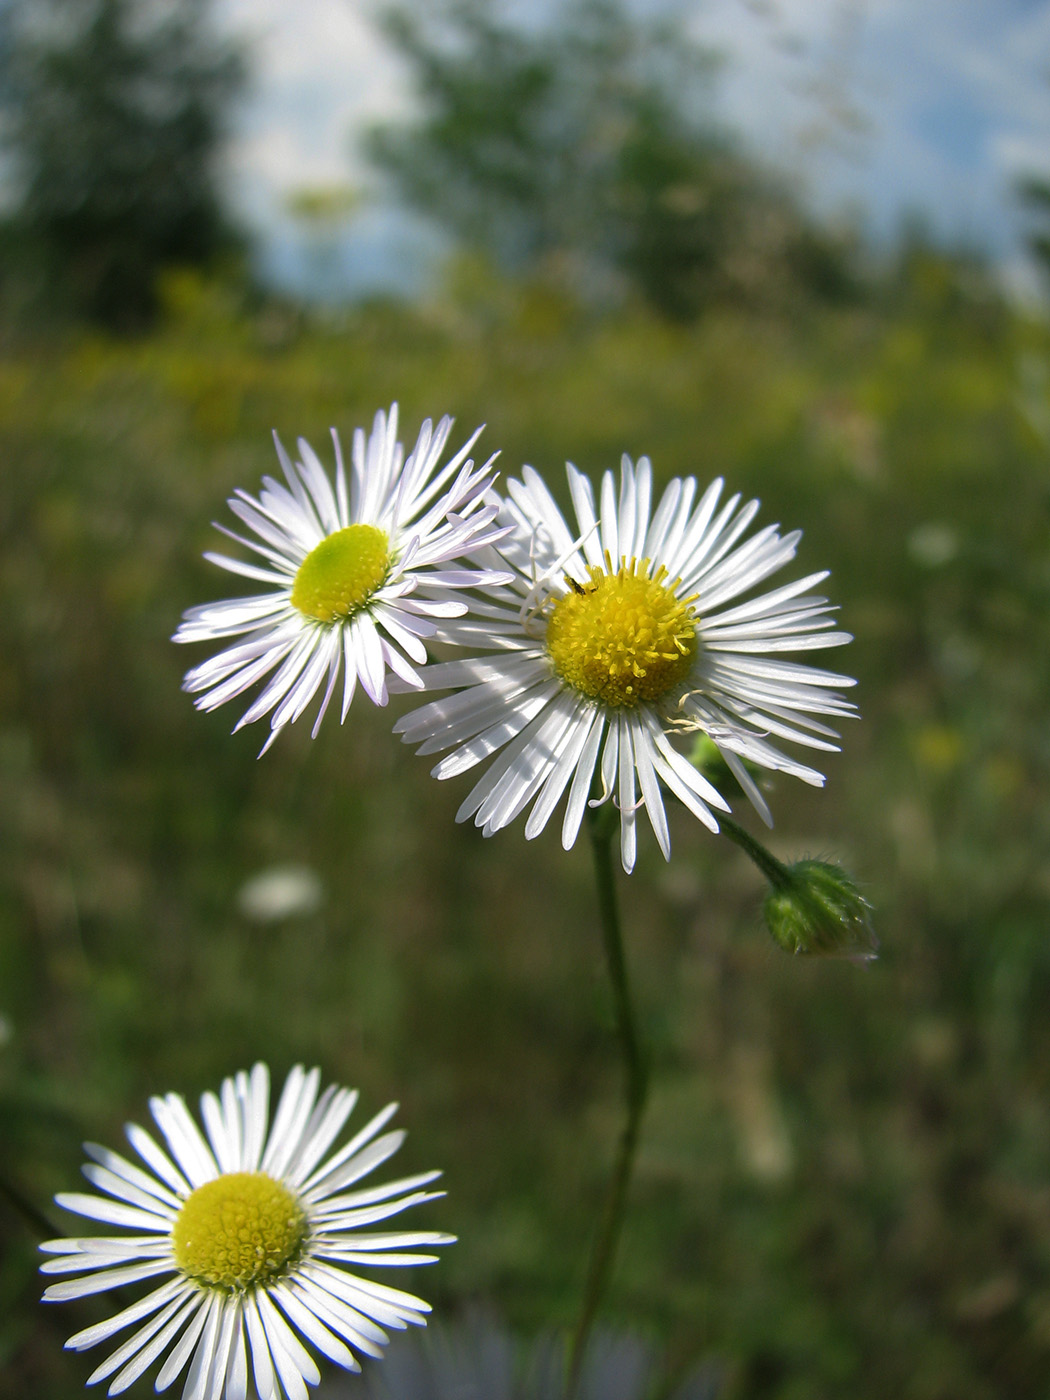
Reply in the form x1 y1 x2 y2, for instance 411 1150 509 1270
0 264 1050 1400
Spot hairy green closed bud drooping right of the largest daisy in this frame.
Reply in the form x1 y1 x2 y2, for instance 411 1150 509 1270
762 860 879 962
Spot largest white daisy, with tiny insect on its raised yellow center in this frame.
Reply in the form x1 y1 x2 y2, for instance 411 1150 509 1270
395 456 854 871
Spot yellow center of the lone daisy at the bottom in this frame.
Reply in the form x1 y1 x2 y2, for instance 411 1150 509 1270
171 1172 307 1292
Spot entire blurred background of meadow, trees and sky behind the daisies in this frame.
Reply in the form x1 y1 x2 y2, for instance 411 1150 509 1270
0 0 1050 1400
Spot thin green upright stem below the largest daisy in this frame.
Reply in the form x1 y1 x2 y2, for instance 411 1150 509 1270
566 804 648 1400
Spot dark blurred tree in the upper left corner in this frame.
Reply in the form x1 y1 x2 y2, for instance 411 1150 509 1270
3 0 245 330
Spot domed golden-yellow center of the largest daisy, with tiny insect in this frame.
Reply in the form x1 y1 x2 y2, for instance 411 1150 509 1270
546 554 697 707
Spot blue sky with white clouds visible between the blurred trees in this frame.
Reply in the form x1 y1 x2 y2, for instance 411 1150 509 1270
218 0 1050 291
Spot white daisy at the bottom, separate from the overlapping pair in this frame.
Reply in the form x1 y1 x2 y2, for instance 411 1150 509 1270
41 1064 454 1400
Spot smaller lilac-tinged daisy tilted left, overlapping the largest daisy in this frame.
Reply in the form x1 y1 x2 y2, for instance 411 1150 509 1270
174 403 512 753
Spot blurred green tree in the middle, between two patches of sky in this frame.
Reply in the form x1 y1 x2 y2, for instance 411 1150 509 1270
368 0 850 319
